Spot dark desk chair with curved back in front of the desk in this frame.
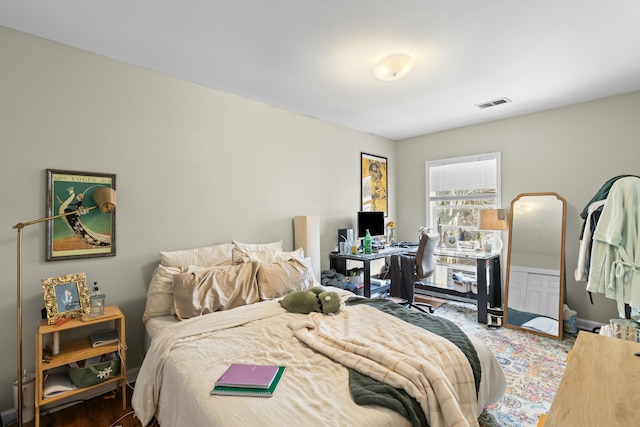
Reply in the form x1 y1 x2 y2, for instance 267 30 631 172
389 232 438 313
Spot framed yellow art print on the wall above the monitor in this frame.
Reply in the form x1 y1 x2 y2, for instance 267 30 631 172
360 153 389 216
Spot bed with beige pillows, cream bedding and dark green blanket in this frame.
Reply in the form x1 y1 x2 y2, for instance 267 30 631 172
132 241 506 427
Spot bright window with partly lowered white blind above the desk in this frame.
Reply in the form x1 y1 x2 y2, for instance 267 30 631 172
426 152 501 243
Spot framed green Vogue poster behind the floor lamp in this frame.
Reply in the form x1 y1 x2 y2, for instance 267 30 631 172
47 169 116 261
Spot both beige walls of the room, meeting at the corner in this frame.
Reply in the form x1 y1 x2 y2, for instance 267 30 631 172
0 22 640 410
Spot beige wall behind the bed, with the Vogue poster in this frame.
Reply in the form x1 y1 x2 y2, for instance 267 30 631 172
0 27 396 410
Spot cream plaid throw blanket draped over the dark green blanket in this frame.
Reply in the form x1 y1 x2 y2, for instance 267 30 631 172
291 305 478 427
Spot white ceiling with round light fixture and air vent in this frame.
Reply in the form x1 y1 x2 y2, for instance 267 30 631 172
0 0 640 140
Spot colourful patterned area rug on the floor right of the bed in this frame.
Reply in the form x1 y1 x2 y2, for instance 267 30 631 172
434 301 575 427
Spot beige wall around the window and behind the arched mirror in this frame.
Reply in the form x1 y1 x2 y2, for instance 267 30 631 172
397 92 640 328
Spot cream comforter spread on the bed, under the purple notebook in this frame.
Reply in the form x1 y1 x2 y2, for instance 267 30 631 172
132 301 505 427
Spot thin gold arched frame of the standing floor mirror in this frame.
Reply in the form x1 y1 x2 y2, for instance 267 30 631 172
503 192 567 340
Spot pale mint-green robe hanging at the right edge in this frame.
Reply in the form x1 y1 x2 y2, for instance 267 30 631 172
587 176 640 317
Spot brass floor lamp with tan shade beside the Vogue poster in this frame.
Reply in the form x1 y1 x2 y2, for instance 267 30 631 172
12 187 116 426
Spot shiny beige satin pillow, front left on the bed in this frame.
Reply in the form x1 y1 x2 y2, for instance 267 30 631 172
173 262 260 319
